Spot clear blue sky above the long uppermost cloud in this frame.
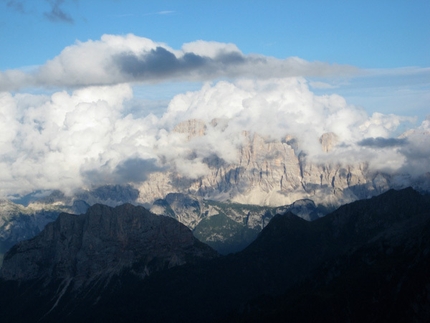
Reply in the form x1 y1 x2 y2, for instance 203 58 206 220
0 0 430 70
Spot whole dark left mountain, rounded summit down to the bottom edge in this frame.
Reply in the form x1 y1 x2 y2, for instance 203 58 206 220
0 204 218 322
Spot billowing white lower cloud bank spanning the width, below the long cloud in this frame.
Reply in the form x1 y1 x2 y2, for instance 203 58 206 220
0 77 430 196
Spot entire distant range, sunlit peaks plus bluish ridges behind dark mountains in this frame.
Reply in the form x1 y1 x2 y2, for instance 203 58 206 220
0 119 430 264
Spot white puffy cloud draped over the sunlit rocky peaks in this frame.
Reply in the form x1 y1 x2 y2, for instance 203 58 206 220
160 78 424 172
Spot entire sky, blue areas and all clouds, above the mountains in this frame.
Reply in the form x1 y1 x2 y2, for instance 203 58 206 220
0 0 430 196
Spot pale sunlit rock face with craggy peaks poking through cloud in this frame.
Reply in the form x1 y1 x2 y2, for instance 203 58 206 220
139 120 410 206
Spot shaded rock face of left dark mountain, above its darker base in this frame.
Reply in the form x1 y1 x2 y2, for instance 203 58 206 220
1 204 217 287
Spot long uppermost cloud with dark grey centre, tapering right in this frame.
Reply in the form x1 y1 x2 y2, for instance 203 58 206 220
0 34 357 91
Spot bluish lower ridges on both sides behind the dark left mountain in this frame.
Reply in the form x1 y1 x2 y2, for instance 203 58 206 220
0 185 326 265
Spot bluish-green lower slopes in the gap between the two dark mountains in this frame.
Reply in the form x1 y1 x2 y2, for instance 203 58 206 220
151 193 325 254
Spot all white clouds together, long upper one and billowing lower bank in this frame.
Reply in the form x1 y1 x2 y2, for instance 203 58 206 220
0 34 430 196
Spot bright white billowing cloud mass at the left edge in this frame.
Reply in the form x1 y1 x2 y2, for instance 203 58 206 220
0 85 153 196
